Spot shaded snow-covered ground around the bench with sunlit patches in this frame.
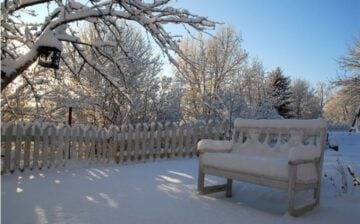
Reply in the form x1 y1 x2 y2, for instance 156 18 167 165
1 132 360 224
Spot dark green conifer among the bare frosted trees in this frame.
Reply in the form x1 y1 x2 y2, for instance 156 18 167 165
267 67 292 118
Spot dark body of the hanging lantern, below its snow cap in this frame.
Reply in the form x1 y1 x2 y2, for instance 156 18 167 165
38 46 61 69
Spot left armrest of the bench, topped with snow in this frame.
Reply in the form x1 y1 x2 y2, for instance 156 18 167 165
197 139 233 153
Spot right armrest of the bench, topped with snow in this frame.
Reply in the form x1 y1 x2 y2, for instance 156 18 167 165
288 146 321 165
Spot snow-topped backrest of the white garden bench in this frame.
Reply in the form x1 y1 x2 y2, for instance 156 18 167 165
232 118 327 155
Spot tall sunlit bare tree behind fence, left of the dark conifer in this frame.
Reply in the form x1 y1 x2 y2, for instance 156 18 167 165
177 27 247 120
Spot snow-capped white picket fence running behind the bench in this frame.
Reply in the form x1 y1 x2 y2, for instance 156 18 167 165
1 121 228 174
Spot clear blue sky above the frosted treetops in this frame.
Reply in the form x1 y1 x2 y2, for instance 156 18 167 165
167 0 360 85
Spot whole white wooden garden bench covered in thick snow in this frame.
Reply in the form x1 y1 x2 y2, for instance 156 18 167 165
197 118 327 216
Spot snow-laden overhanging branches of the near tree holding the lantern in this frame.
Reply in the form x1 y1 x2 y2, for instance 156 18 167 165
1 0 215 89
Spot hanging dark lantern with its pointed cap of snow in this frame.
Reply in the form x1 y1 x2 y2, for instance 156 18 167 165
37 31 63 69
